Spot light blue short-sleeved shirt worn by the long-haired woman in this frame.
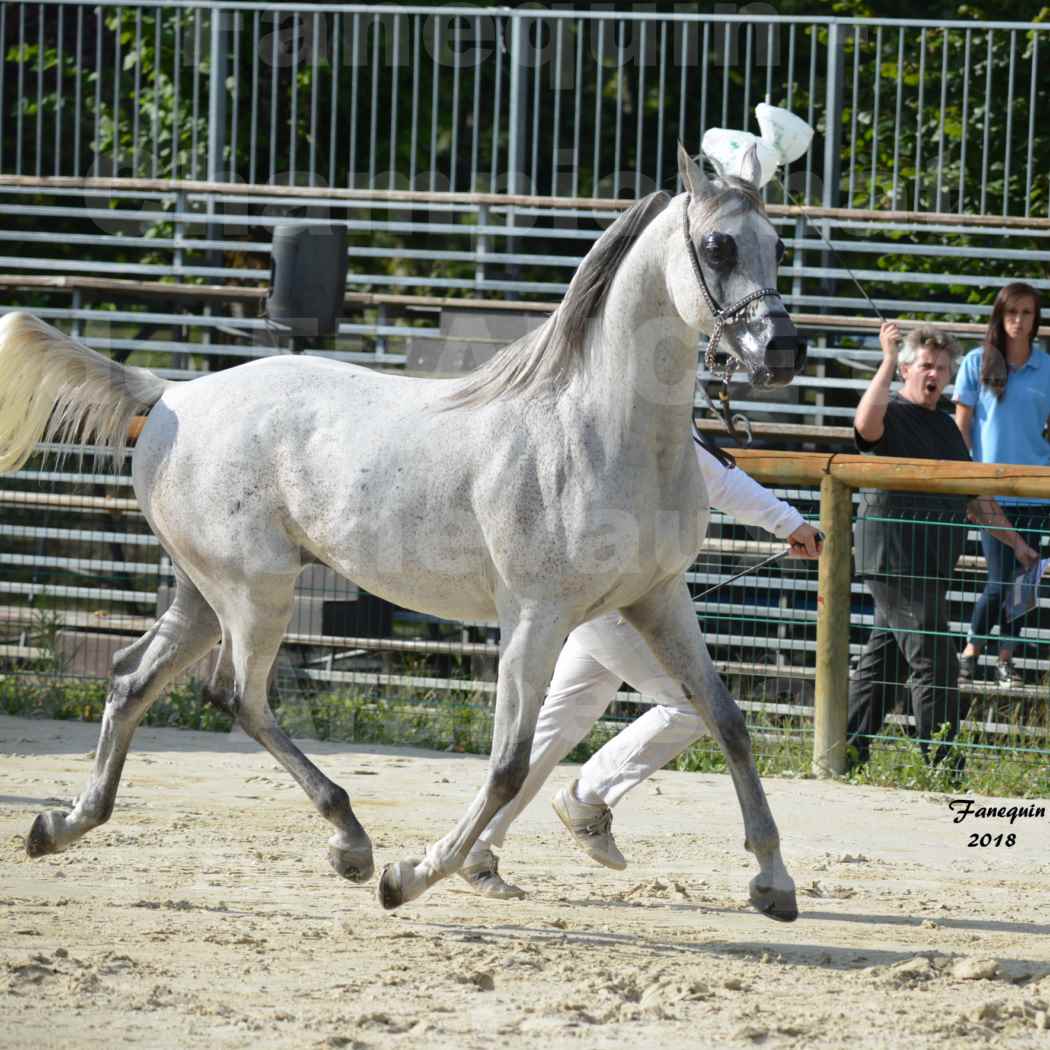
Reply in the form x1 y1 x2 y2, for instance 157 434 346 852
953 347 1050 503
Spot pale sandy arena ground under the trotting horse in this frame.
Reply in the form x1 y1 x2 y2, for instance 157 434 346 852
0 718 1050 1050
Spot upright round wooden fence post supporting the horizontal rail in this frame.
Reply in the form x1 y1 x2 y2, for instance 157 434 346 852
813 474 853 777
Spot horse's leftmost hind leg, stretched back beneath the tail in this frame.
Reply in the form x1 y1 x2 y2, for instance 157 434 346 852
25 569 219 857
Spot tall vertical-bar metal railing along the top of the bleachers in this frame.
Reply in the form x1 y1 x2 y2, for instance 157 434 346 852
0 0 1050 214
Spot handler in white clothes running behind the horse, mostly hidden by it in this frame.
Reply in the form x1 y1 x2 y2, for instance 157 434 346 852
459 434 820 898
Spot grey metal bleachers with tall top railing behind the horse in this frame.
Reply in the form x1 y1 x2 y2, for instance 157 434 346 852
0 0 1050 772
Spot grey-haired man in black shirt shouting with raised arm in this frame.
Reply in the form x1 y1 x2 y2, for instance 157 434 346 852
847 322 1038 770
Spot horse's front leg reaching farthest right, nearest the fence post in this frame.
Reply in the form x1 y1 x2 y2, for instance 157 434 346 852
623 578 798 922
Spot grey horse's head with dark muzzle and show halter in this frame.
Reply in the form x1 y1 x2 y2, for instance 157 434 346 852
671 146 805 386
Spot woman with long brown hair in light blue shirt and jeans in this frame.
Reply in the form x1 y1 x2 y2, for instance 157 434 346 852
954 281 1050 688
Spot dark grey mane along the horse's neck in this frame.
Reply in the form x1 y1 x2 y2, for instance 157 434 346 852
448 190 671 405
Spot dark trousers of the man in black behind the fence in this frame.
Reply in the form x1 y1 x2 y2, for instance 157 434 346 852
847 576 969 768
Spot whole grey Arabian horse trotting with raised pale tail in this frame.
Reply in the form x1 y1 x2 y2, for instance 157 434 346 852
0 149 804 921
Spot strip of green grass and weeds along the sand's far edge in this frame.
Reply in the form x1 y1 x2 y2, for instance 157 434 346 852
0 672 1050 798
